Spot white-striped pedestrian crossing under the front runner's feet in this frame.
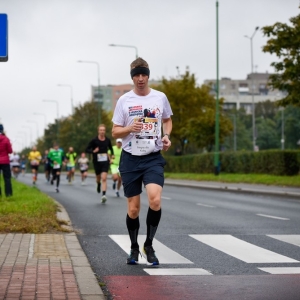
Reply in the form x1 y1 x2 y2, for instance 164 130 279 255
109 234 300 276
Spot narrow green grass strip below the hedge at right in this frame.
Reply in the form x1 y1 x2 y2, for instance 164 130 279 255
165 173 300 187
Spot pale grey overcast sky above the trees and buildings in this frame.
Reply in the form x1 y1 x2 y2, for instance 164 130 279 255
0 0 299 151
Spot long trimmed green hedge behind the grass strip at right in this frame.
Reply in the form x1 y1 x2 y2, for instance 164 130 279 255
165 150 300 176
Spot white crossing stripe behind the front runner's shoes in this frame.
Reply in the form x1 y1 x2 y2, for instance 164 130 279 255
109 235 193 264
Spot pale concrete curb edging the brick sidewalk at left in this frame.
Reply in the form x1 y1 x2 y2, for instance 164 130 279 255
52 198 106 300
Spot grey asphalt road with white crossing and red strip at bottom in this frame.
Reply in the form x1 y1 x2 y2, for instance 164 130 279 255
20 175 300 299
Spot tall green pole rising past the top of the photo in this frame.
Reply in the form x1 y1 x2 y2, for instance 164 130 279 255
214 1 220 175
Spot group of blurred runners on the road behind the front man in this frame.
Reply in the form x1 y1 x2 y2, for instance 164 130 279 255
6 129 122 197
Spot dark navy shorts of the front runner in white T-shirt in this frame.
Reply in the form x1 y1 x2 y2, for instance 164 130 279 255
119 150 166 198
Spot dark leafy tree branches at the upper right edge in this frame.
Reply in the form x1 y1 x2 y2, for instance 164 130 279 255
262 15 300 106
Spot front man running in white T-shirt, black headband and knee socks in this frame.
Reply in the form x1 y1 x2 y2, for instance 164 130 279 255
112 58 173 265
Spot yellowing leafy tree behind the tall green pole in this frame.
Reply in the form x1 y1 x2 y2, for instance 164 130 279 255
155 70 232 153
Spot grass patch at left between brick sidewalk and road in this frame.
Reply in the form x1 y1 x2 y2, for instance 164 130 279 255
0 177 66 233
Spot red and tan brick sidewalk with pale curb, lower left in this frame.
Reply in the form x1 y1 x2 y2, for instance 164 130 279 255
0 205 105 300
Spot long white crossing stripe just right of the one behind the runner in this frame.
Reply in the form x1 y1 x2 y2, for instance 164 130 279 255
190 234 298 263
